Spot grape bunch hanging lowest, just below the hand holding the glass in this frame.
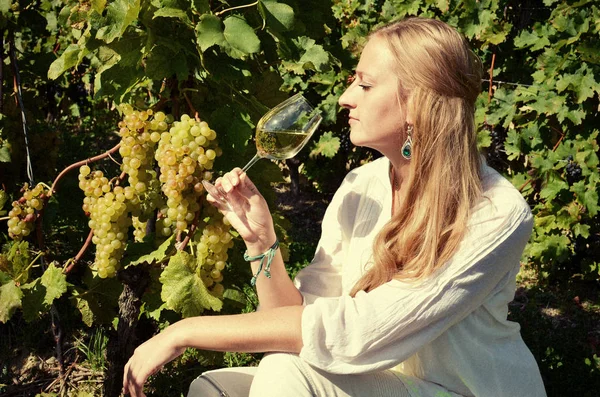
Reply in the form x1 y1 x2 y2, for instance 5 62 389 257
195 206 233 297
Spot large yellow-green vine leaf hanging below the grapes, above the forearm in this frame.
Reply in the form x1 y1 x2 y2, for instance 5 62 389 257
160 251 223 317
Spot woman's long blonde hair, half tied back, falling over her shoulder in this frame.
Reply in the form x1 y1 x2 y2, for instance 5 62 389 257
351 18 482 296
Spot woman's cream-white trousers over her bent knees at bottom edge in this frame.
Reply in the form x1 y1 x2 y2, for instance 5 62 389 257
187 353 410 397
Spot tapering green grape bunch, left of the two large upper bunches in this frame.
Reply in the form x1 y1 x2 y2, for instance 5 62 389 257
79 165 135 278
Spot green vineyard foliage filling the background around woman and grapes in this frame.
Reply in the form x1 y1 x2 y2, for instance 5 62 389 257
0 0 600 368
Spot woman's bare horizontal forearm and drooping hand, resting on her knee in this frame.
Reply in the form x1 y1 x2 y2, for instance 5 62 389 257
123 306 304 397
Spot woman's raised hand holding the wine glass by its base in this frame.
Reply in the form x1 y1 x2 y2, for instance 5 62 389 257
207 168 276 252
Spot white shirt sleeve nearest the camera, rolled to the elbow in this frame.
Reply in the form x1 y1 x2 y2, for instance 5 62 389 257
300 187 532 374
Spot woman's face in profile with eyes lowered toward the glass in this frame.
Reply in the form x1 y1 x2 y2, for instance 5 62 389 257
339 36 407 158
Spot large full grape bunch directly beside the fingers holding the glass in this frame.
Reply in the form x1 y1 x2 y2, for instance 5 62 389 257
155 114 222 236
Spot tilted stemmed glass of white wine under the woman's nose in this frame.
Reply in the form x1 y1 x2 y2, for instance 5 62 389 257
202 94 323 204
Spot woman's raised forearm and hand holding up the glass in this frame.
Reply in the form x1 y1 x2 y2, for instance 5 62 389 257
208 168 302 310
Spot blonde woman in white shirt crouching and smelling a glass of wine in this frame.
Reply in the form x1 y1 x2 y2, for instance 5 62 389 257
124 18 545 397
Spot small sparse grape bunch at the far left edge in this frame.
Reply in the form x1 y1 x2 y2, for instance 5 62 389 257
8 183 49 241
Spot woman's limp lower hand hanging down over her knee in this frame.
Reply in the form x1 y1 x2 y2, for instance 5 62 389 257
123 328 185 397
